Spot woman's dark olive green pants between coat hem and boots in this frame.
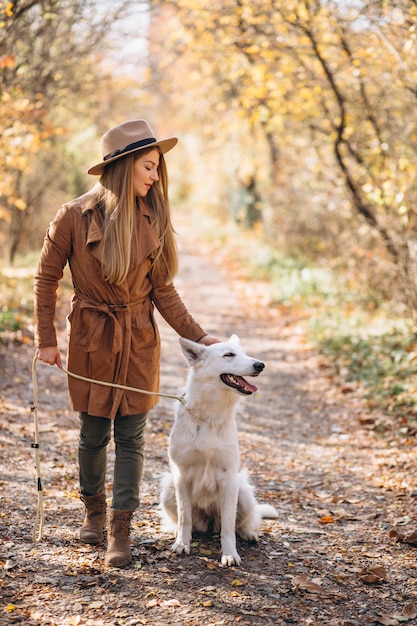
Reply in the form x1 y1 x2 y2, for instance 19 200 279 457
78 413 147 511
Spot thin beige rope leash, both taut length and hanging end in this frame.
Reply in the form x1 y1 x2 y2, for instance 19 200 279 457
31 356 185 543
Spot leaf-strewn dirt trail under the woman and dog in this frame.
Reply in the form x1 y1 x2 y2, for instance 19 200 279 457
0 224 417 626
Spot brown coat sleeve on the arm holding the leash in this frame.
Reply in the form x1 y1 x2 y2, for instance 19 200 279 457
34 206 72 348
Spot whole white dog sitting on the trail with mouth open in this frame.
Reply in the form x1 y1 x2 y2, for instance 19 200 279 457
161 335 278 566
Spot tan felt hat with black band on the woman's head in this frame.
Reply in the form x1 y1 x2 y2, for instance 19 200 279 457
87 120 178 175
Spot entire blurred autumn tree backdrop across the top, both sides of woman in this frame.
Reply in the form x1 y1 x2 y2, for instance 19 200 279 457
0 0 417 315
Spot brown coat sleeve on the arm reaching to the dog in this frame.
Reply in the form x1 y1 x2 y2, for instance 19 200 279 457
152 283 207 341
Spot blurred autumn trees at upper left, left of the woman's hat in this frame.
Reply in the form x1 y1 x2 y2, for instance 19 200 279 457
0 0 143 262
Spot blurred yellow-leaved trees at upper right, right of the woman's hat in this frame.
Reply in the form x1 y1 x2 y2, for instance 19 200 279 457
148 0 417 320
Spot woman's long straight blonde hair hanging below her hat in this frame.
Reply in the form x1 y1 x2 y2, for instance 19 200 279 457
95 148 178 285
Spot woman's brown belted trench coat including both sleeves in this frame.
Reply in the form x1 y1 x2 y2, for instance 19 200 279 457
35 194 206 419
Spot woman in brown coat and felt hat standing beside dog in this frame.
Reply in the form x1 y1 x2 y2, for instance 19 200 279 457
35 120 217 567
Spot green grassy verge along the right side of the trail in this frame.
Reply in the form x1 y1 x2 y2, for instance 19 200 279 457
254 241 417 423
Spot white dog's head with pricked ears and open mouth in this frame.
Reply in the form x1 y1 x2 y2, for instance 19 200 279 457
180 335 265 396
